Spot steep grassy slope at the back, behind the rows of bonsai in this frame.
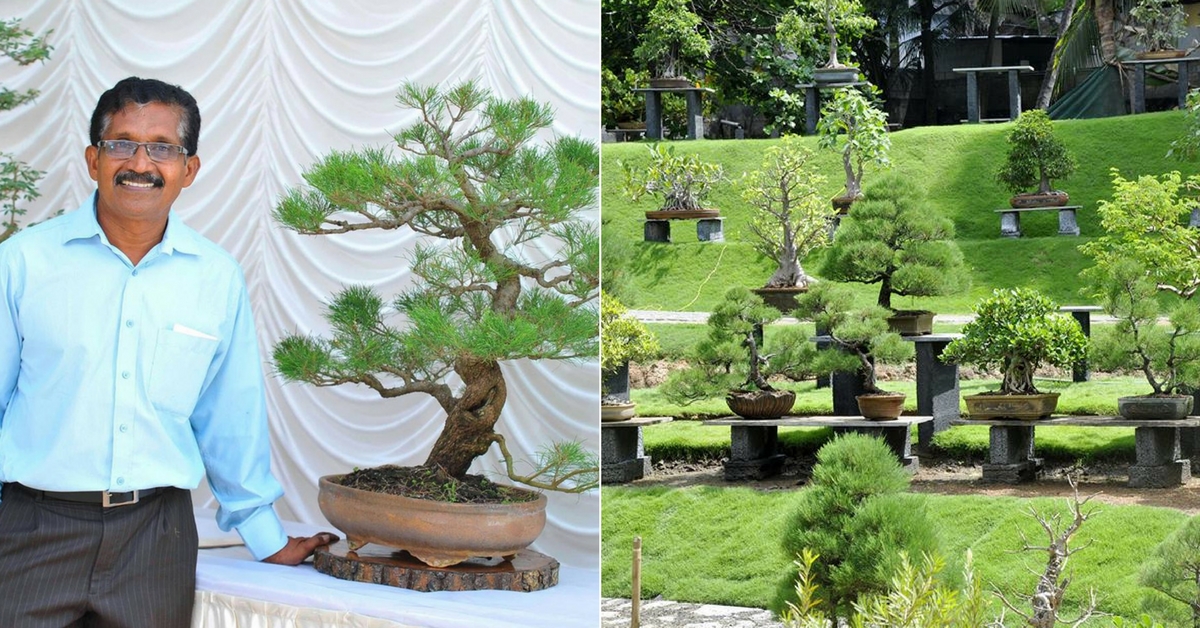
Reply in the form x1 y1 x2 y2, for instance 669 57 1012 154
601 112 1187 312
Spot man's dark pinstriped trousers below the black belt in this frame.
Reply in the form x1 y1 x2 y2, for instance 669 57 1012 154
0 484 198 628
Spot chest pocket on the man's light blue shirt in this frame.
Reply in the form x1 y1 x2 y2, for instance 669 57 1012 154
148 329 218 417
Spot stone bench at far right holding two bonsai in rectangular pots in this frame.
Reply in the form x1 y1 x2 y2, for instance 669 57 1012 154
950 417 1200 489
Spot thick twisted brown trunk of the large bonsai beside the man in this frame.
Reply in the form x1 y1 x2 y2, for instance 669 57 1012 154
425 359 508 479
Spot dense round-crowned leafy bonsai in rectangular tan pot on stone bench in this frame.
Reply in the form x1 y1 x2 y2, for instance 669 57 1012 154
942 288 1087 419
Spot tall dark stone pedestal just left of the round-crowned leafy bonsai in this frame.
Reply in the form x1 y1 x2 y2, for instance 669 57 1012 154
904 334 962 451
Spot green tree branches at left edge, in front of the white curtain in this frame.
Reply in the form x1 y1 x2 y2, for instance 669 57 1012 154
0 19 54 241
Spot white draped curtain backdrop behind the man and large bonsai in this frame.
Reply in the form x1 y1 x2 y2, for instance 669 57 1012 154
0 0 600 568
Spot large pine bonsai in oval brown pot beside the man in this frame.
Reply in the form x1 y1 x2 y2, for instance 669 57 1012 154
274 82 599 567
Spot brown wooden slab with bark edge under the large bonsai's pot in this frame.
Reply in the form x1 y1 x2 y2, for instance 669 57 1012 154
313 540 558 592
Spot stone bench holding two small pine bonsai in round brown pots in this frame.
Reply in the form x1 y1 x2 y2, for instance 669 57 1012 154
703 417 934 480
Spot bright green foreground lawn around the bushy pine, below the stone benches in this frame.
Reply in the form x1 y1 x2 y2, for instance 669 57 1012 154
601 489 1190 627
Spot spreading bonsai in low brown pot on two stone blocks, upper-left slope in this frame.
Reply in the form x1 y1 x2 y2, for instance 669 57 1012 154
618 143 725 220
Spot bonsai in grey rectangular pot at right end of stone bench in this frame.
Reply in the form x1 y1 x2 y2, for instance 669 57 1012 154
1092 259 1200 419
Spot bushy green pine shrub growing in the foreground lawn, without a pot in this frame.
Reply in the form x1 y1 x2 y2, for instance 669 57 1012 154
772 433 937 616
